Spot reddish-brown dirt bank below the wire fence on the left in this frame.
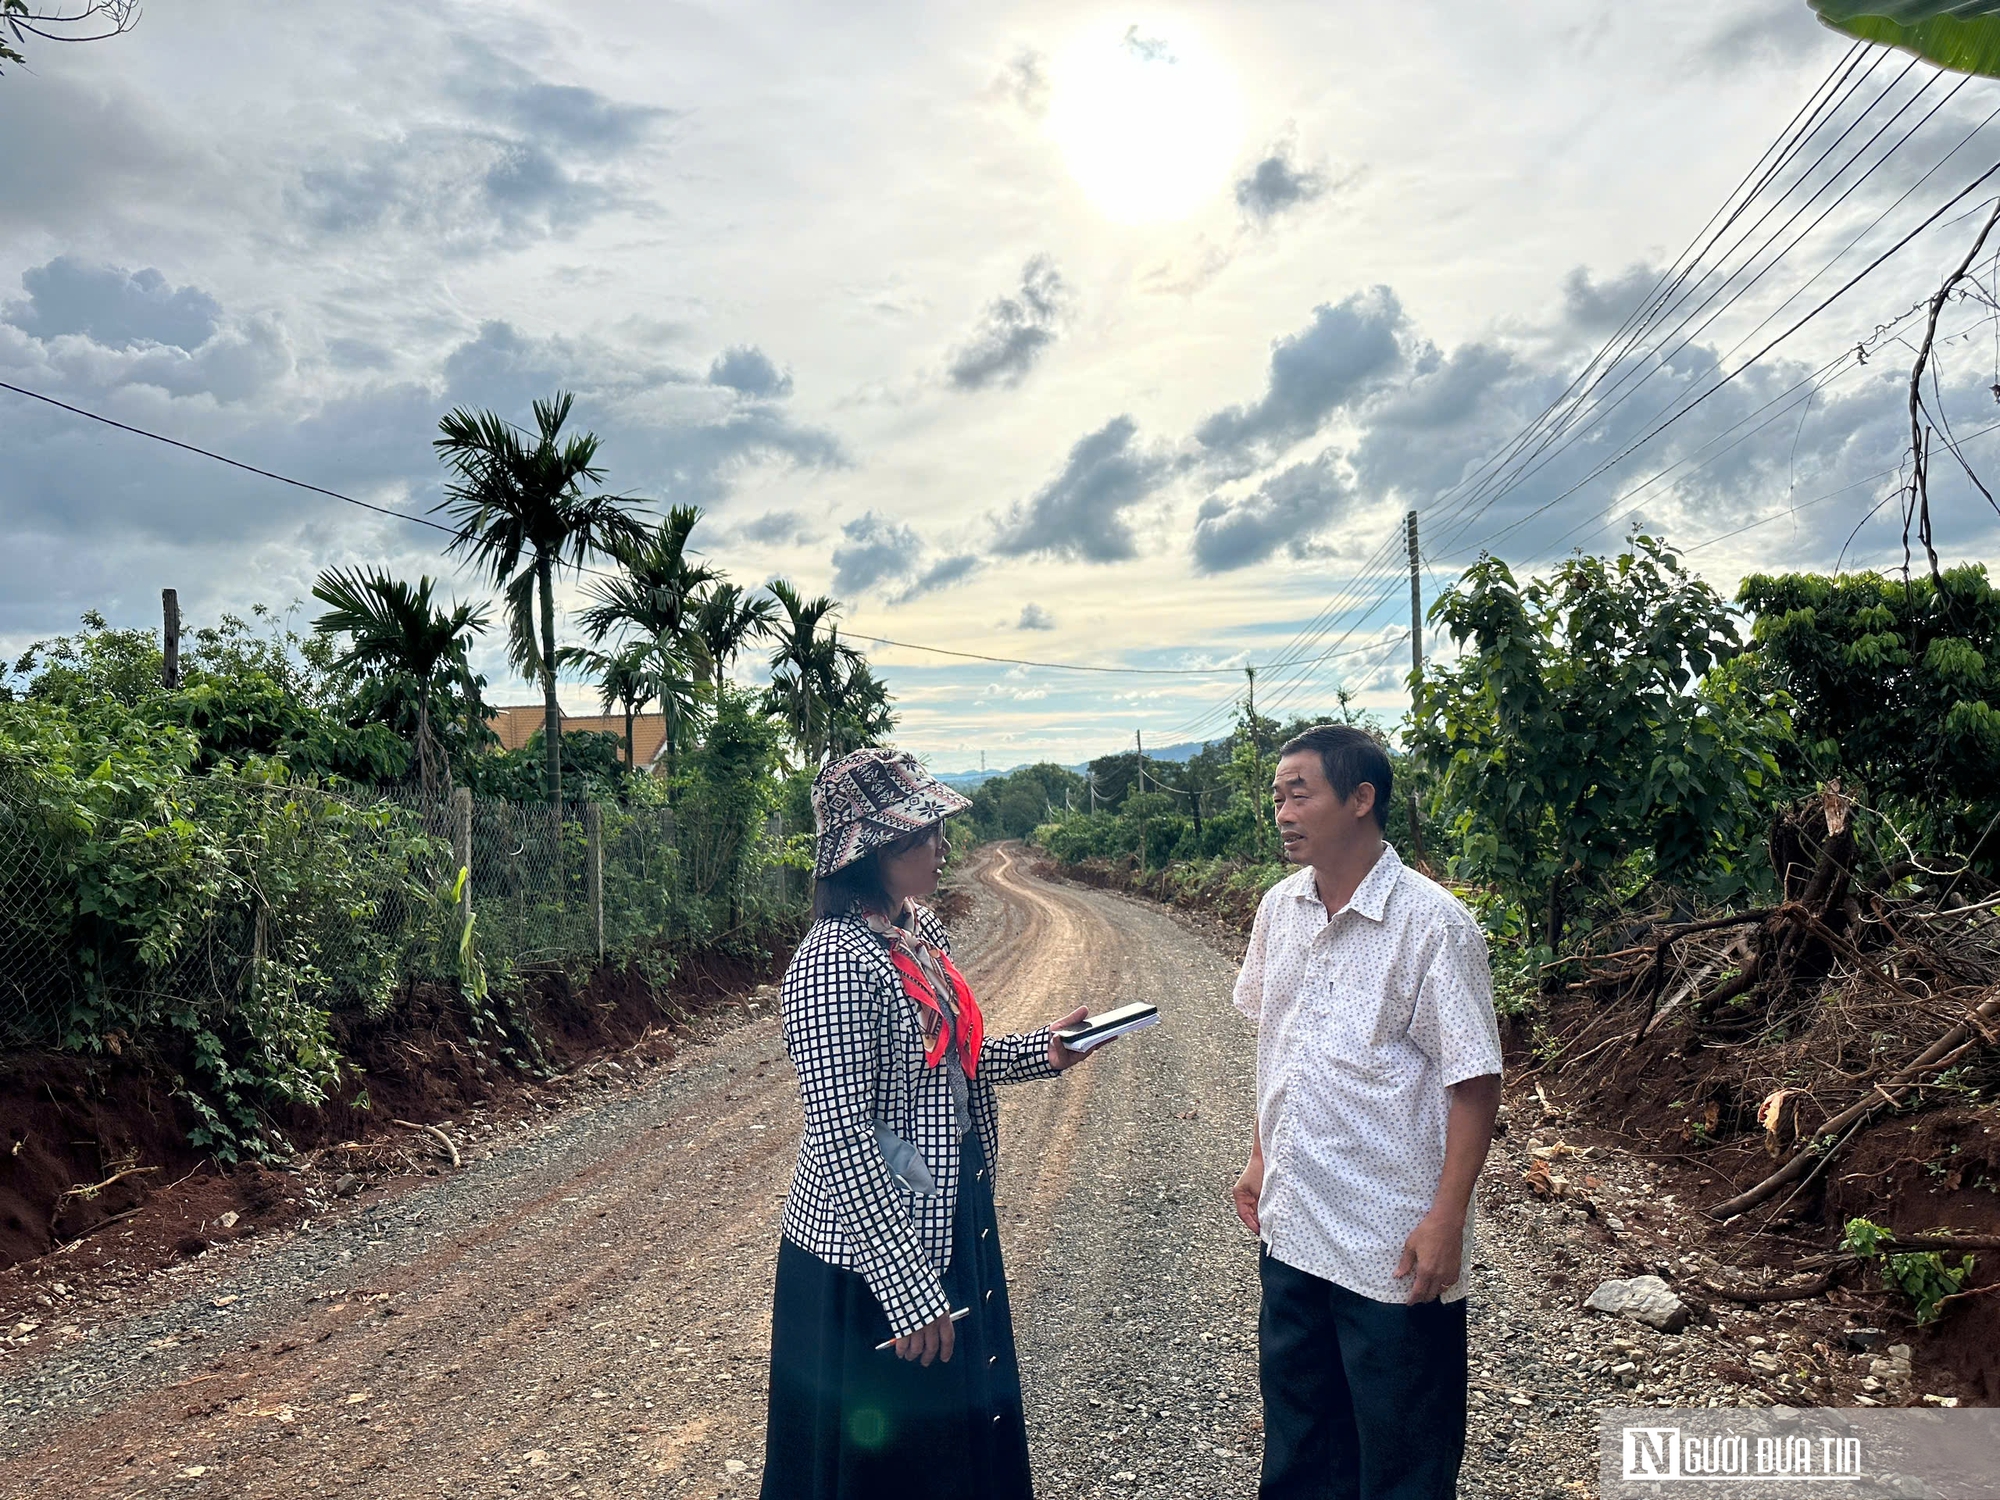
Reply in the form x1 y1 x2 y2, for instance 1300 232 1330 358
0 952 786 1268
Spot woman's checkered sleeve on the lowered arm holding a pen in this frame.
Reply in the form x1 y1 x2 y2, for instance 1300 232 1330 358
784 944 952 1338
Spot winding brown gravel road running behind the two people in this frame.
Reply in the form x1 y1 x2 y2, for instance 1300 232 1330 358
0 846 1784 1500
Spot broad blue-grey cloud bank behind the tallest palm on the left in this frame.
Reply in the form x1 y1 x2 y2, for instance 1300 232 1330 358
0 276 846 634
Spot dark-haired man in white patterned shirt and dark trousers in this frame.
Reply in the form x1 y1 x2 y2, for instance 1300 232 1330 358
1236 724 1500 1500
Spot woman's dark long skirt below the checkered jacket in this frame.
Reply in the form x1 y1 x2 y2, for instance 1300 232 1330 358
764 1130 1034 1500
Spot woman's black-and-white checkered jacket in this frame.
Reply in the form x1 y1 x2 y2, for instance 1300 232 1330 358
784 906 1058 1338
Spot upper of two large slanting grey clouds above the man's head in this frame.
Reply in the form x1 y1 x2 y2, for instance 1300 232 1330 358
1194 286 1408 460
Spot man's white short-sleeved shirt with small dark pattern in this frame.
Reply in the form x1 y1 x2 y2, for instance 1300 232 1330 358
1236 844 1500 1302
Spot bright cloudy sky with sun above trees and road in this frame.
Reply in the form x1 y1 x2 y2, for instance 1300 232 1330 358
0 0 2000 770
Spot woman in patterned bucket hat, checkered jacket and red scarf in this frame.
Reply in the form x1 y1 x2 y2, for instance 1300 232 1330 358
764 750 1084 1500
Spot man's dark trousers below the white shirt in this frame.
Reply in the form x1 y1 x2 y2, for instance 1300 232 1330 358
1256 1248 1466 1500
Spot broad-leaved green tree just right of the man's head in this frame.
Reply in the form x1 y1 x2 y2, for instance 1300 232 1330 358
1412 536 1788 950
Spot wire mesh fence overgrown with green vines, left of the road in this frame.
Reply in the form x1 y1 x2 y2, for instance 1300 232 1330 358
0 776 788 1046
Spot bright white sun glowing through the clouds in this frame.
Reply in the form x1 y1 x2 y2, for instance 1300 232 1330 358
1048 20 1242 224
